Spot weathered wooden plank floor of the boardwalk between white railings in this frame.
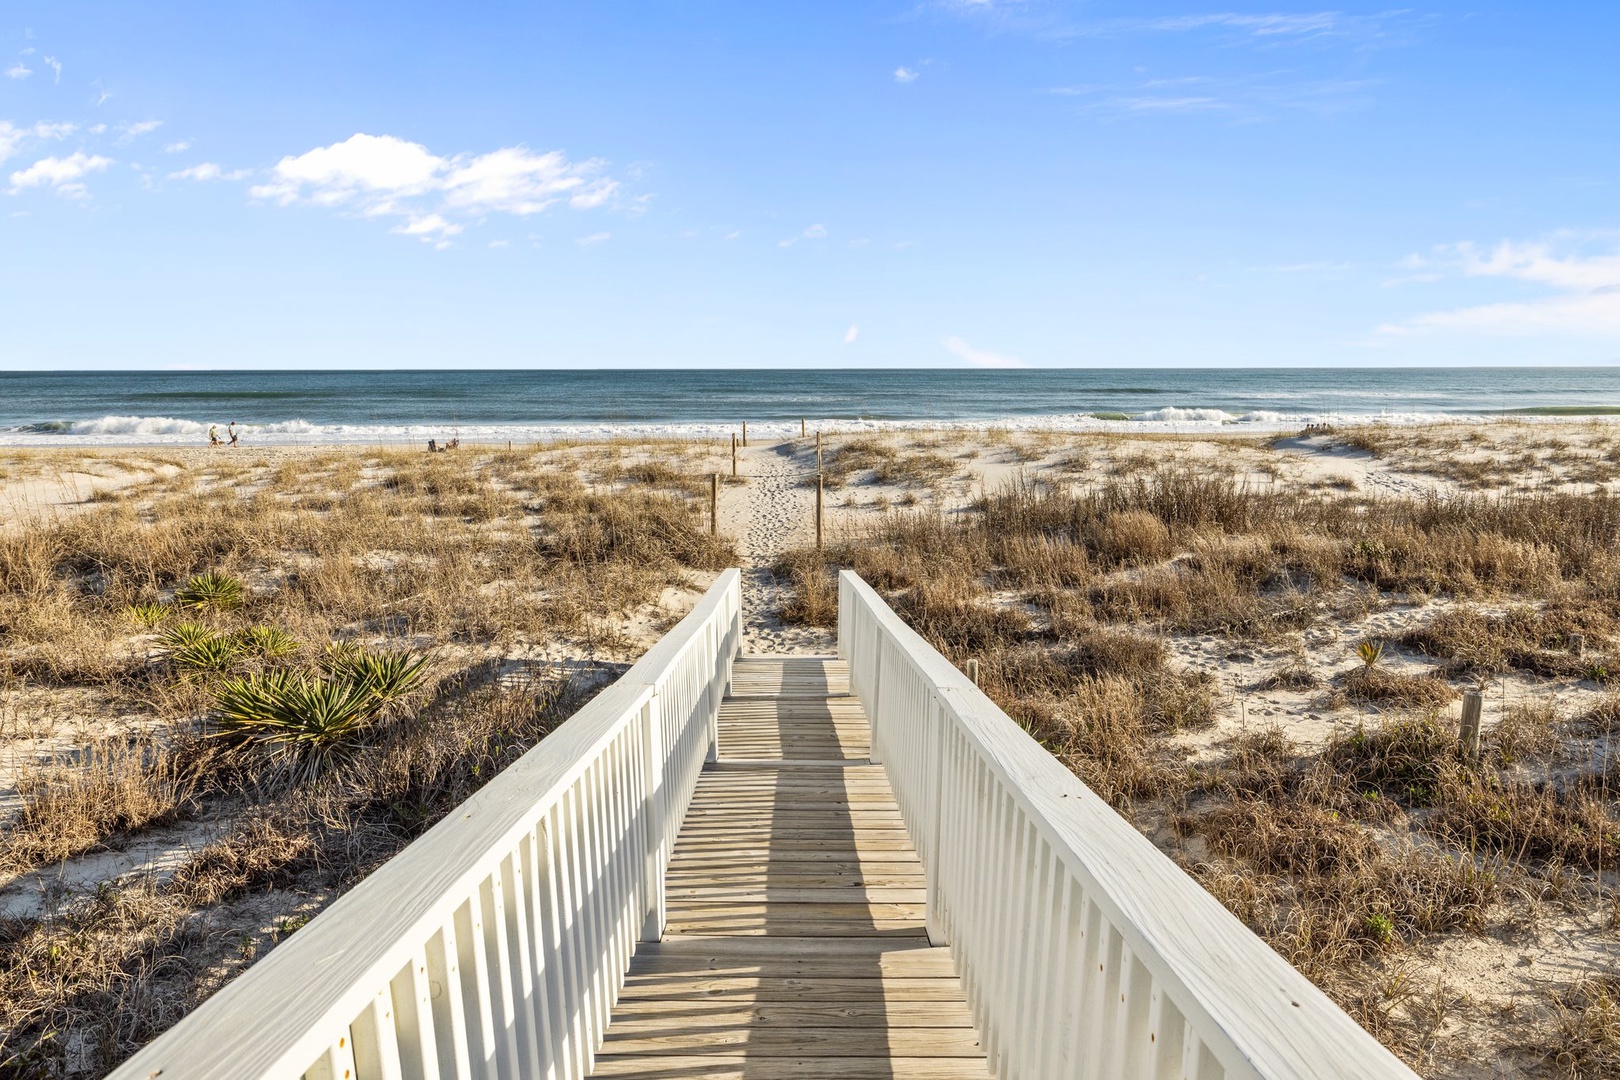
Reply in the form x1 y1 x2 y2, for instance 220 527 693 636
591 657 988 1080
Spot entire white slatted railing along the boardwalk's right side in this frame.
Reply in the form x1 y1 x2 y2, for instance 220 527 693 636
838 572 1416 1080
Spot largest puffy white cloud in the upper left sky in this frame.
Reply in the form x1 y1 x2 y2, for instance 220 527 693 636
249 134 620 235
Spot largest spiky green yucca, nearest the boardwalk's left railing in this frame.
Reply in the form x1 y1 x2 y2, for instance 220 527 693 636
214 670 382 776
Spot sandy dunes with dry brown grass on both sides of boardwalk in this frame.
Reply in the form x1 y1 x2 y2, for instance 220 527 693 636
0 424 1620 1078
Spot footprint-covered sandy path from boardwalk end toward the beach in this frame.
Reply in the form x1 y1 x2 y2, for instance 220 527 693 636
719 442 838 656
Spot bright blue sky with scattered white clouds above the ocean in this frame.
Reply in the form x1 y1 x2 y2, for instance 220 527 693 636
0 0 1620 369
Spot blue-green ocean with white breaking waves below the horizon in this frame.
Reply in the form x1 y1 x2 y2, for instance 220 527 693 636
0 368 1620 447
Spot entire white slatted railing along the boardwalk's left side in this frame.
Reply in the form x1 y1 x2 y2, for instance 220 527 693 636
113 570 742 1080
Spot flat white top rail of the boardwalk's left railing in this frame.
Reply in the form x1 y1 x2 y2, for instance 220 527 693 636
113 568 739 1080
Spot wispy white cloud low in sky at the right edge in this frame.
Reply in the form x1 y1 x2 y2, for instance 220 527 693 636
1379 233 1620 337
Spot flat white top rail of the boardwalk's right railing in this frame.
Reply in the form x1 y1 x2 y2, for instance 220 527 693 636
842 570 1414 1080
